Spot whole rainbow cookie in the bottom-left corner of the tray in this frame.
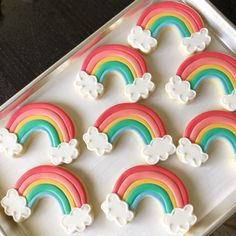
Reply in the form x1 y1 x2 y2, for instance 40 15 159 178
1 166 93 233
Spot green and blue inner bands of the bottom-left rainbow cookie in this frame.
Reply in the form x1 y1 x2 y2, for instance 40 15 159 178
26 184 71 214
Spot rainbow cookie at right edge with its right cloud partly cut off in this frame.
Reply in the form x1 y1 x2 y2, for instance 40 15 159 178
165 52 236 111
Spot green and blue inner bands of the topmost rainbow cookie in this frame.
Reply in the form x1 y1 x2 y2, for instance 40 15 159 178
149 16 191 38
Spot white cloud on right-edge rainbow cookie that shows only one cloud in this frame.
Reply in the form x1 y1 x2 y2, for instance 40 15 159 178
176 138 208 167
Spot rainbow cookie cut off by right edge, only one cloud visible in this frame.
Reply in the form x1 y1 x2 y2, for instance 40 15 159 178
176 111 236 167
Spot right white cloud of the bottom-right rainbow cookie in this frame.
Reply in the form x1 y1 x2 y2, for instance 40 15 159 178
164 204 197 235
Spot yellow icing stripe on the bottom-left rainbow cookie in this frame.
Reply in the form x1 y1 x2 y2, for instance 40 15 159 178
23 179 76 208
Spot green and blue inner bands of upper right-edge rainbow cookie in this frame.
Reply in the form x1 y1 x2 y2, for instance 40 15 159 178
189 69 234 94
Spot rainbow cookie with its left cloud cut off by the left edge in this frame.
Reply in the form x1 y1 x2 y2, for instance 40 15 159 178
0 103 79 165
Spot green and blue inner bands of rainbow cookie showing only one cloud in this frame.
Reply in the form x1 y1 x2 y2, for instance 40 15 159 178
199 128 236 153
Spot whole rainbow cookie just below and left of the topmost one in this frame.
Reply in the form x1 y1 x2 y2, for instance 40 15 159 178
74 44 155 102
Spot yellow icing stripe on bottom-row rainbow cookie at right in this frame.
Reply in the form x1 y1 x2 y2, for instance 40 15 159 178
122 179 177 208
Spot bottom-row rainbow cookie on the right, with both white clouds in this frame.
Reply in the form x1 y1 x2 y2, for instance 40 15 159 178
101 166 197 235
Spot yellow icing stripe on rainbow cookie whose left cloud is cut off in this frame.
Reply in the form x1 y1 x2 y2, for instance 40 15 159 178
14 115 64 142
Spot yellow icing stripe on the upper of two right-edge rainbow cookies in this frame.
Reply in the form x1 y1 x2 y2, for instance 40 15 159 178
186 64 236 88
